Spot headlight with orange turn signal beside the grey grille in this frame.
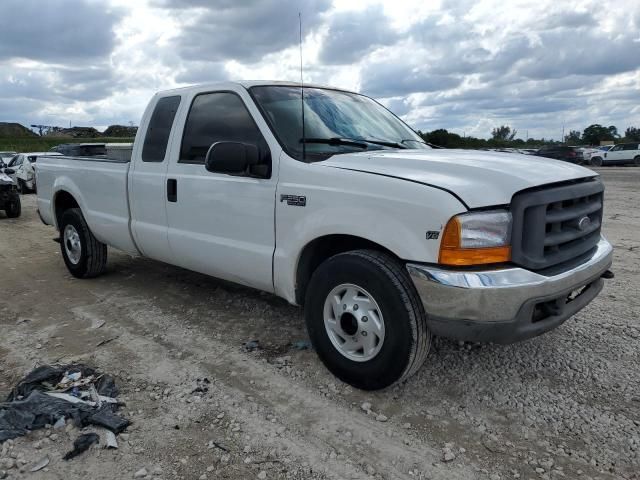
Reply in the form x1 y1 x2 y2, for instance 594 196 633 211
439 210 511 265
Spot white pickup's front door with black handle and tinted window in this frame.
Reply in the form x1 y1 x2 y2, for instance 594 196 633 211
165 90 279 291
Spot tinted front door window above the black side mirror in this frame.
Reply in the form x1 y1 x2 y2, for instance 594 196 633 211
179 92 268 164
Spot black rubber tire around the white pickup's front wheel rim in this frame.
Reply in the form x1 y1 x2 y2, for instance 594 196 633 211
305 250 431 390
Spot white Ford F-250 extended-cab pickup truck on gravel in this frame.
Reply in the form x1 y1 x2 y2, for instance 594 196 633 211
37 82 612 389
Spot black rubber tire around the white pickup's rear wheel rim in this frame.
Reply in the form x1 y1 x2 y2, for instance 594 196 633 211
59 208 107 278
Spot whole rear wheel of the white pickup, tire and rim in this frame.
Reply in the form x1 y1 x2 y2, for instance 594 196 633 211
59 208 107 278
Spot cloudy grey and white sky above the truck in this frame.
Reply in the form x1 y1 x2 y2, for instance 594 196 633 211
0 0 640 139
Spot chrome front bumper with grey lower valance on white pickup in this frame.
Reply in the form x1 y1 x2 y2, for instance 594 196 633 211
407 238 613 343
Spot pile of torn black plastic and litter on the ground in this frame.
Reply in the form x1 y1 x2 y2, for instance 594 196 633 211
0 365 130 443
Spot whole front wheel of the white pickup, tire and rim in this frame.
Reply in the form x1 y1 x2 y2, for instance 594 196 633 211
305 250 431 390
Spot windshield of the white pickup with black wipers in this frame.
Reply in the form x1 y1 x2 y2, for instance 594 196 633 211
250 86 430 161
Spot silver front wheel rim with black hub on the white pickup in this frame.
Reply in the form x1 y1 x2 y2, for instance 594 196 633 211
324 283 385 362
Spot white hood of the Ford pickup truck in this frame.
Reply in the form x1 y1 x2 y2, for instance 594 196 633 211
317 149 597 208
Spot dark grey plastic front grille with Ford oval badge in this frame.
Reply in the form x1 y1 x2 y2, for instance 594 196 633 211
511 178 604 270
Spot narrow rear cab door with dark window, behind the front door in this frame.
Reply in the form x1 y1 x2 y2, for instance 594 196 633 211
129 95 181 262
